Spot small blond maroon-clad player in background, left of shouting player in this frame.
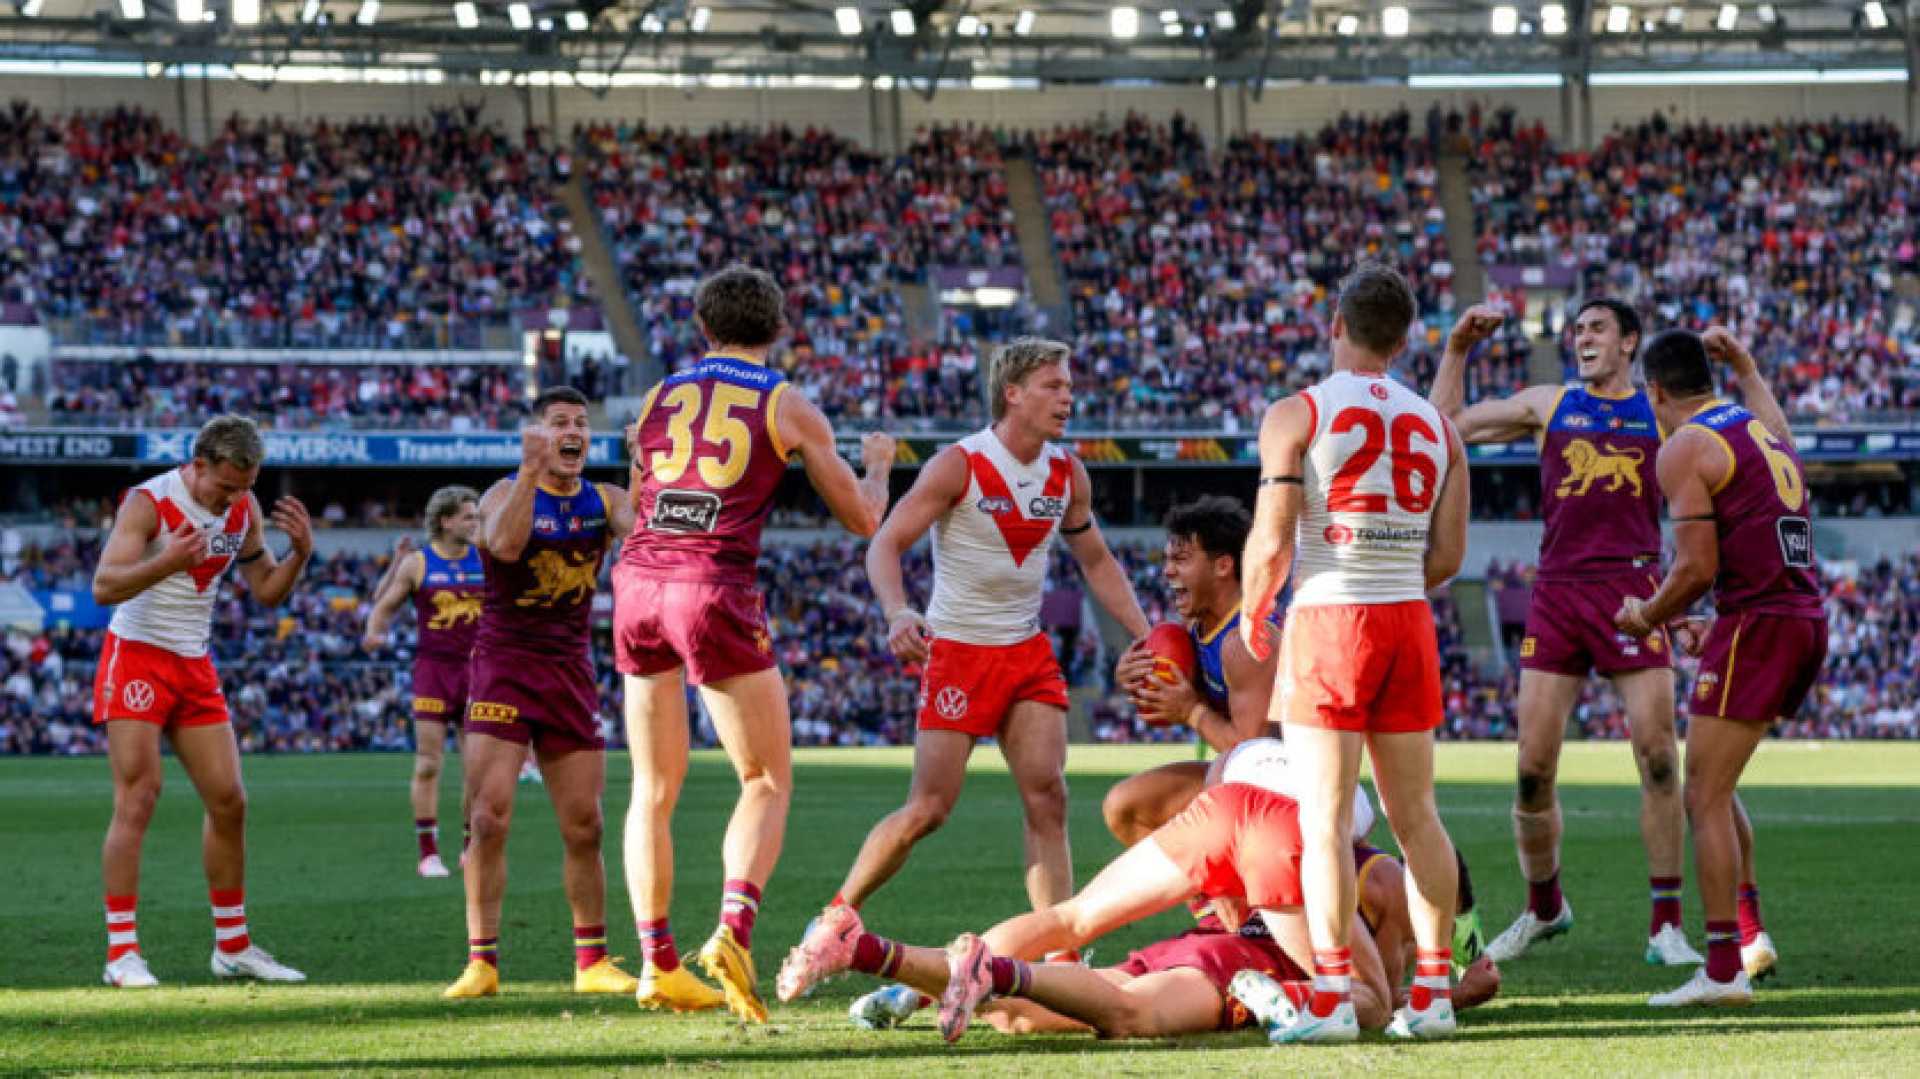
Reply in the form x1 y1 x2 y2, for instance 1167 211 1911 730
361 486 486 877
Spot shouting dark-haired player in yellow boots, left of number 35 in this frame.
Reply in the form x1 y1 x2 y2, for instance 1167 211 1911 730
445 386 636 998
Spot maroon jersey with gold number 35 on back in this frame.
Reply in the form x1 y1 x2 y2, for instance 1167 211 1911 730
620 353 789 586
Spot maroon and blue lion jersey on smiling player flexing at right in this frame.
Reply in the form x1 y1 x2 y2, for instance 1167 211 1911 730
1540 386 1661 580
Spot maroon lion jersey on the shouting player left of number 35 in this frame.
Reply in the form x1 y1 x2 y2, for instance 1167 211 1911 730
474 482 609 659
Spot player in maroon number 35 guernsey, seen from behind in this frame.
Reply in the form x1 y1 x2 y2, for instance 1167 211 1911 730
614 267 895 1023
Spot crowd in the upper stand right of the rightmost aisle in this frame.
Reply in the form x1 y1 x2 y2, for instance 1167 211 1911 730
1469 111 1920 422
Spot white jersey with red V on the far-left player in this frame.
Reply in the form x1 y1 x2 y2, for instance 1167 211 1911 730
108 468 252 659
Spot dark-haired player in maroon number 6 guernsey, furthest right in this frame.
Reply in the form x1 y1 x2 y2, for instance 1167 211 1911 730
1615 328 1826 1006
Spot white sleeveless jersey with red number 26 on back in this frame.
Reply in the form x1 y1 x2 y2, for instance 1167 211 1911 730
1294 371 1450 607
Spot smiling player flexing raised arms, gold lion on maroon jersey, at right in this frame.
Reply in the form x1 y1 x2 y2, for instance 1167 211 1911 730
1430 300 1701 966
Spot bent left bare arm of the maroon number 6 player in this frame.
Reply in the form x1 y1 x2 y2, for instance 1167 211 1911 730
1613 426 1734 637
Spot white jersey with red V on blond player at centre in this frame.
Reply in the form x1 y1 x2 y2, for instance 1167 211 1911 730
927 428 1073 645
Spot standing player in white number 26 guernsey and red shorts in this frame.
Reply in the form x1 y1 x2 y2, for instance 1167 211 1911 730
1240 265 1467 1043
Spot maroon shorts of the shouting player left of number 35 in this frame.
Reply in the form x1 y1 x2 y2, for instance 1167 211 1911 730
465 645 607 753
